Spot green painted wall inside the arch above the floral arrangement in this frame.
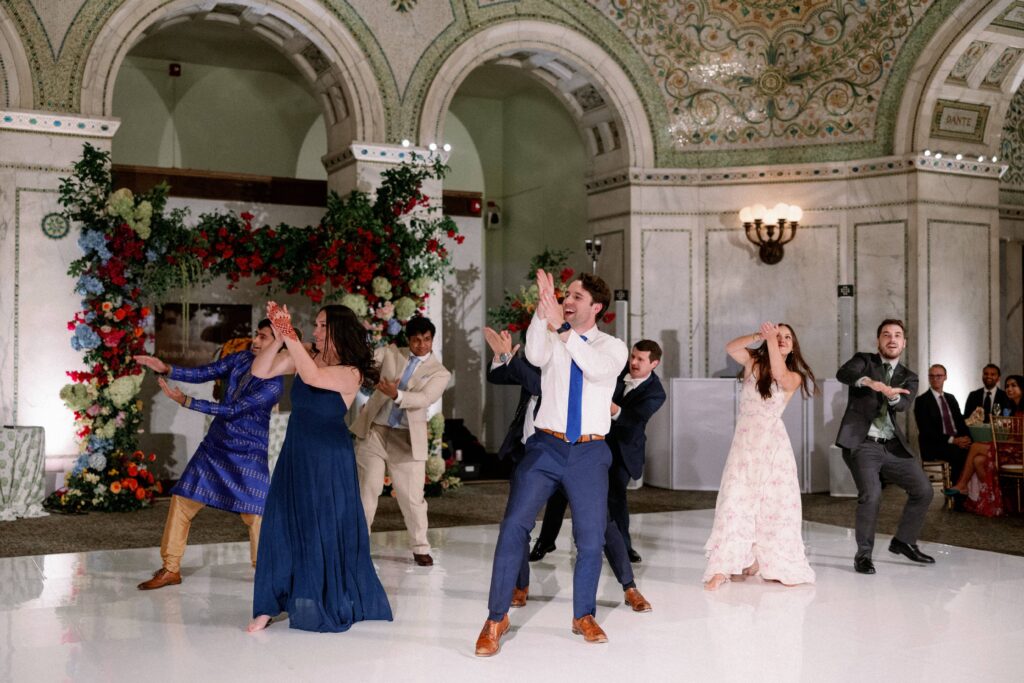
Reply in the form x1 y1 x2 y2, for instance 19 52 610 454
113 57 327 179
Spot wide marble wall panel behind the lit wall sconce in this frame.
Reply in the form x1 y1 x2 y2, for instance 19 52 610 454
703 224 840 377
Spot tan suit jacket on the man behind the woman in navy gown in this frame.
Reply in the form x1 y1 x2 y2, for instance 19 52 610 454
352 344 452 460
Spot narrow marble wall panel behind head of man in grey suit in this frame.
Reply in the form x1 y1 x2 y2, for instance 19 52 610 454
852 220 908 350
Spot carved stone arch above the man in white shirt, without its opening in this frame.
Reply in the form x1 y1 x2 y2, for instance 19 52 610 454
417 19 655 174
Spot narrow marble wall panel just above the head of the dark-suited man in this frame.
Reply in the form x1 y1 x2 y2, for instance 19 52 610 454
633 227 696 377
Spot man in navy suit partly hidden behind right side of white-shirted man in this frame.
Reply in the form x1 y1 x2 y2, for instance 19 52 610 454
529 339 665 567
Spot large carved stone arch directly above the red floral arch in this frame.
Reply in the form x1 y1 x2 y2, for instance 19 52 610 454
81 0 388 154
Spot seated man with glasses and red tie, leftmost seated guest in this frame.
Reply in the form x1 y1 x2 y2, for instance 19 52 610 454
913 364 971 480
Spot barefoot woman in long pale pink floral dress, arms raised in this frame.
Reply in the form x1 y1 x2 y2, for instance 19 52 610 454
703 323 814 591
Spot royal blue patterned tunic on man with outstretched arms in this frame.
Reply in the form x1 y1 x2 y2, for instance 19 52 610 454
170 351 285 515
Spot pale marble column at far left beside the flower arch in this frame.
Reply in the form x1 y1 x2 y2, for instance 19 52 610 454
0 111 119 457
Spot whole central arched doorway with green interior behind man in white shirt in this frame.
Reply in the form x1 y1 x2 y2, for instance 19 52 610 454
419 22 653 449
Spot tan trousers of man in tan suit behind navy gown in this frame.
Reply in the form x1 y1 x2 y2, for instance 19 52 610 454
355 424 430 555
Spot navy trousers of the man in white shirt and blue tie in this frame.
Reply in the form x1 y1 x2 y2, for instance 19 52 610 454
487 432 611 621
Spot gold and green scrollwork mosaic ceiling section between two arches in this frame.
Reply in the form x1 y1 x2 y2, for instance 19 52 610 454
590 0 933 151
